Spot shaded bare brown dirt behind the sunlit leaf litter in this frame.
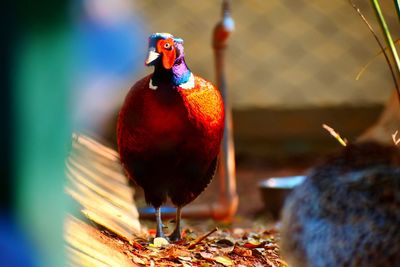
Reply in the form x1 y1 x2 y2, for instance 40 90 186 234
135 156 318 228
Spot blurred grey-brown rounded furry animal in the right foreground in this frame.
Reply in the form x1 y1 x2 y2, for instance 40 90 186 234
281 142 400 267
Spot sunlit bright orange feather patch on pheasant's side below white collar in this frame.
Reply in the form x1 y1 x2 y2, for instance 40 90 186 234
178 76 225 135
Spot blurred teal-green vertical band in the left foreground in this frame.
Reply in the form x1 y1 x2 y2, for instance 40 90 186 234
12 1 72 267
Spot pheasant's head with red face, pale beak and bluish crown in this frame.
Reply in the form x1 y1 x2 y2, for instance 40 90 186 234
145 33 183 70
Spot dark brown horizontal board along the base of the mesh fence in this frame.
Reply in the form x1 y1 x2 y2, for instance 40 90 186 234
233 105 382 160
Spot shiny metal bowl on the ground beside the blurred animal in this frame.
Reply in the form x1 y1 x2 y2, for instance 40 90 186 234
258 175 306 219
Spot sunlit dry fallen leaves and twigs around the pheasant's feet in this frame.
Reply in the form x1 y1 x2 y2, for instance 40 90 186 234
104 229 287 267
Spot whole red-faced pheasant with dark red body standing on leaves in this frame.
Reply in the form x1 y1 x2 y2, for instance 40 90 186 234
117 33 225 241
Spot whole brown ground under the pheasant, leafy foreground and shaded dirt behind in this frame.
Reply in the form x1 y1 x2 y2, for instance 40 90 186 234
75 158 317 266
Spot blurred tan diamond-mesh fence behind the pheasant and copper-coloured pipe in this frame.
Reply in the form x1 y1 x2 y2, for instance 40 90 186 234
133 0 400 108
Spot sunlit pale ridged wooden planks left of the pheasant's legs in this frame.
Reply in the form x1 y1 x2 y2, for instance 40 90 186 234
65 134 143 266
